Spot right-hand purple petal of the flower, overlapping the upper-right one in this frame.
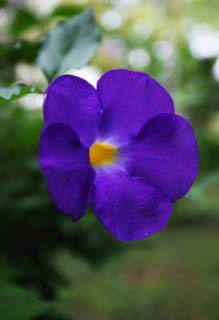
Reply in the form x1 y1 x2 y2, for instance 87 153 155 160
121 113 199 201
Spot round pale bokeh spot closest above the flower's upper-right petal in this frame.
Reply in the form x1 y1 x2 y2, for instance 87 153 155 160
128 48 151 69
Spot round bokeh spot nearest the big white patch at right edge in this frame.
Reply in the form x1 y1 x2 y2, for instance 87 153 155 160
153 40 174 61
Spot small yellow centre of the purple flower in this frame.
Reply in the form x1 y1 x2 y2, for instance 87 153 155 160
89 142 118 167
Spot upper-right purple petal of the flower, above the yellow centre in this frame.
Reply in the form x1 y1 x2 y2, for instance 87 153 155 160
97 69 174 145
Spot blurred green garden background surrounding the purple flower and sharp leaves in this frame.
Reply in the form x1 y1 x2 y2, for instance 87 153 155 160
0 0 219 320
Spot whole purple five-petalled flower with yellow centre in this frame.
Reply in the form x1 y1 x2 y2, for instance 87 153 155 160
40 70 198 241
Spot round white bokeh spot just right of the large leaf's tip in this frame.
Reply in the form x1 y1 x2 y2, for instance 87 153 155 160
100 10 123 31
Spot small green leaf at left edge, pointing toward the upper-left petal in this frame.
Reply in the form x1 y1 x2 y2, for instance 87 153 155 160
0 84 40 103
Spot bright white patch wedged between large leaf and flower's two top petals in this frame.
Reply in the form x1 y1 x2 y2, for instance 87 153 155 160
67 66 101 88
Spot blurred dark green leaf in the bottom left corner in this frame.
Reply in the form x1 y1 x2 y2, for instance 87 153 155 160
0 283 49 320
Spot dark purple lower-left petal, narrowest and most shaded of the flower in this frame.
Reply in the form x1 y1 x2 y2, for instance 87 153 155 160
39 124 94 221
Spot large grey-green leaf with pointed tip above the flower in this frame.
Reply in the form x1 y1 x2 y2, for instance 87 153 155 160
37 9 100 81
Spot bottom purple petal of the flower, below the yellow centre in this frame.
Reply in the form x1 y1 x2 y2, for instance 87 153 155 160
92 169 172 241
